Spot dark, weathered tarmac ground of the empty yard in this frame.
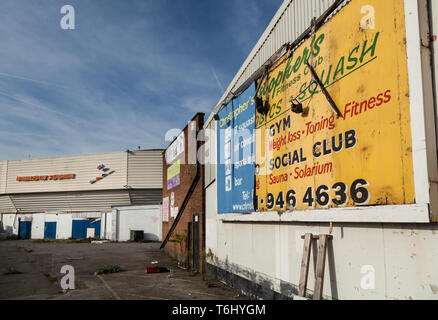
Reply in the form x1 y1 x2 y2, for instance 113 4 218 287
0 240 245 300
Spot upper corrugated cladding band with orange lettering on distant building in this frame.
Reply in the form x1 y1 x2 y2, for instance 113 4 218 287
0 150 163 194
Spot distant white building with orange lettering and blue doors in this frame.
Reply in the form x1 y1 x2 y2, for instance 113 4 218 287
0 150 163 241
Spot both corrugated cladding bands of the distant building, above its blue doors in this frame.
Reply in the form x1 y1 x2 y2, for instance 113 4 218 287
0 150 163 213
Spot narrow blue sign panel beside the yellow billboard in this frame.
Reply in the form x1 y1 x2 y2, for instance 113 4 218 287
217 85 255 213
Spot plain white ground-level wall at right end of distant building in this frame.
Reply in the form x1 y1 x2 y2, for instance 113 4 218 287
112 205 162 241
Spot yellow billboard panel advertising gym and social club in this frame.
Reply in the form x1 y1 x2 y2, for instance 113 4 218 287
255 0 415 211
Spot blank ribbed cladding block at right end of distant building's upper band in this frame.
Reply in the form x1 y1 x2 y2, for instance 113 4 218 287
127 150 164 189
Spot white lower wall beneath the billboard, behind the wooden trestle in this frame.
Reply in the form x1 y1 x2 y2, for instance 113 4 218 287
206 183 438 299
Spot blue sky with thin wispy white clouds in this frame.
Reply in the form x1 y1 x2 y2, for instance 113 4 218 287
0 0 282 161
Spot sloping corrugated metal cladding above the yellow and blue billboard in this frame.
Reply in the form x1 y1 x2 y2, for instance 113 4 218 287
206 0 336 124
